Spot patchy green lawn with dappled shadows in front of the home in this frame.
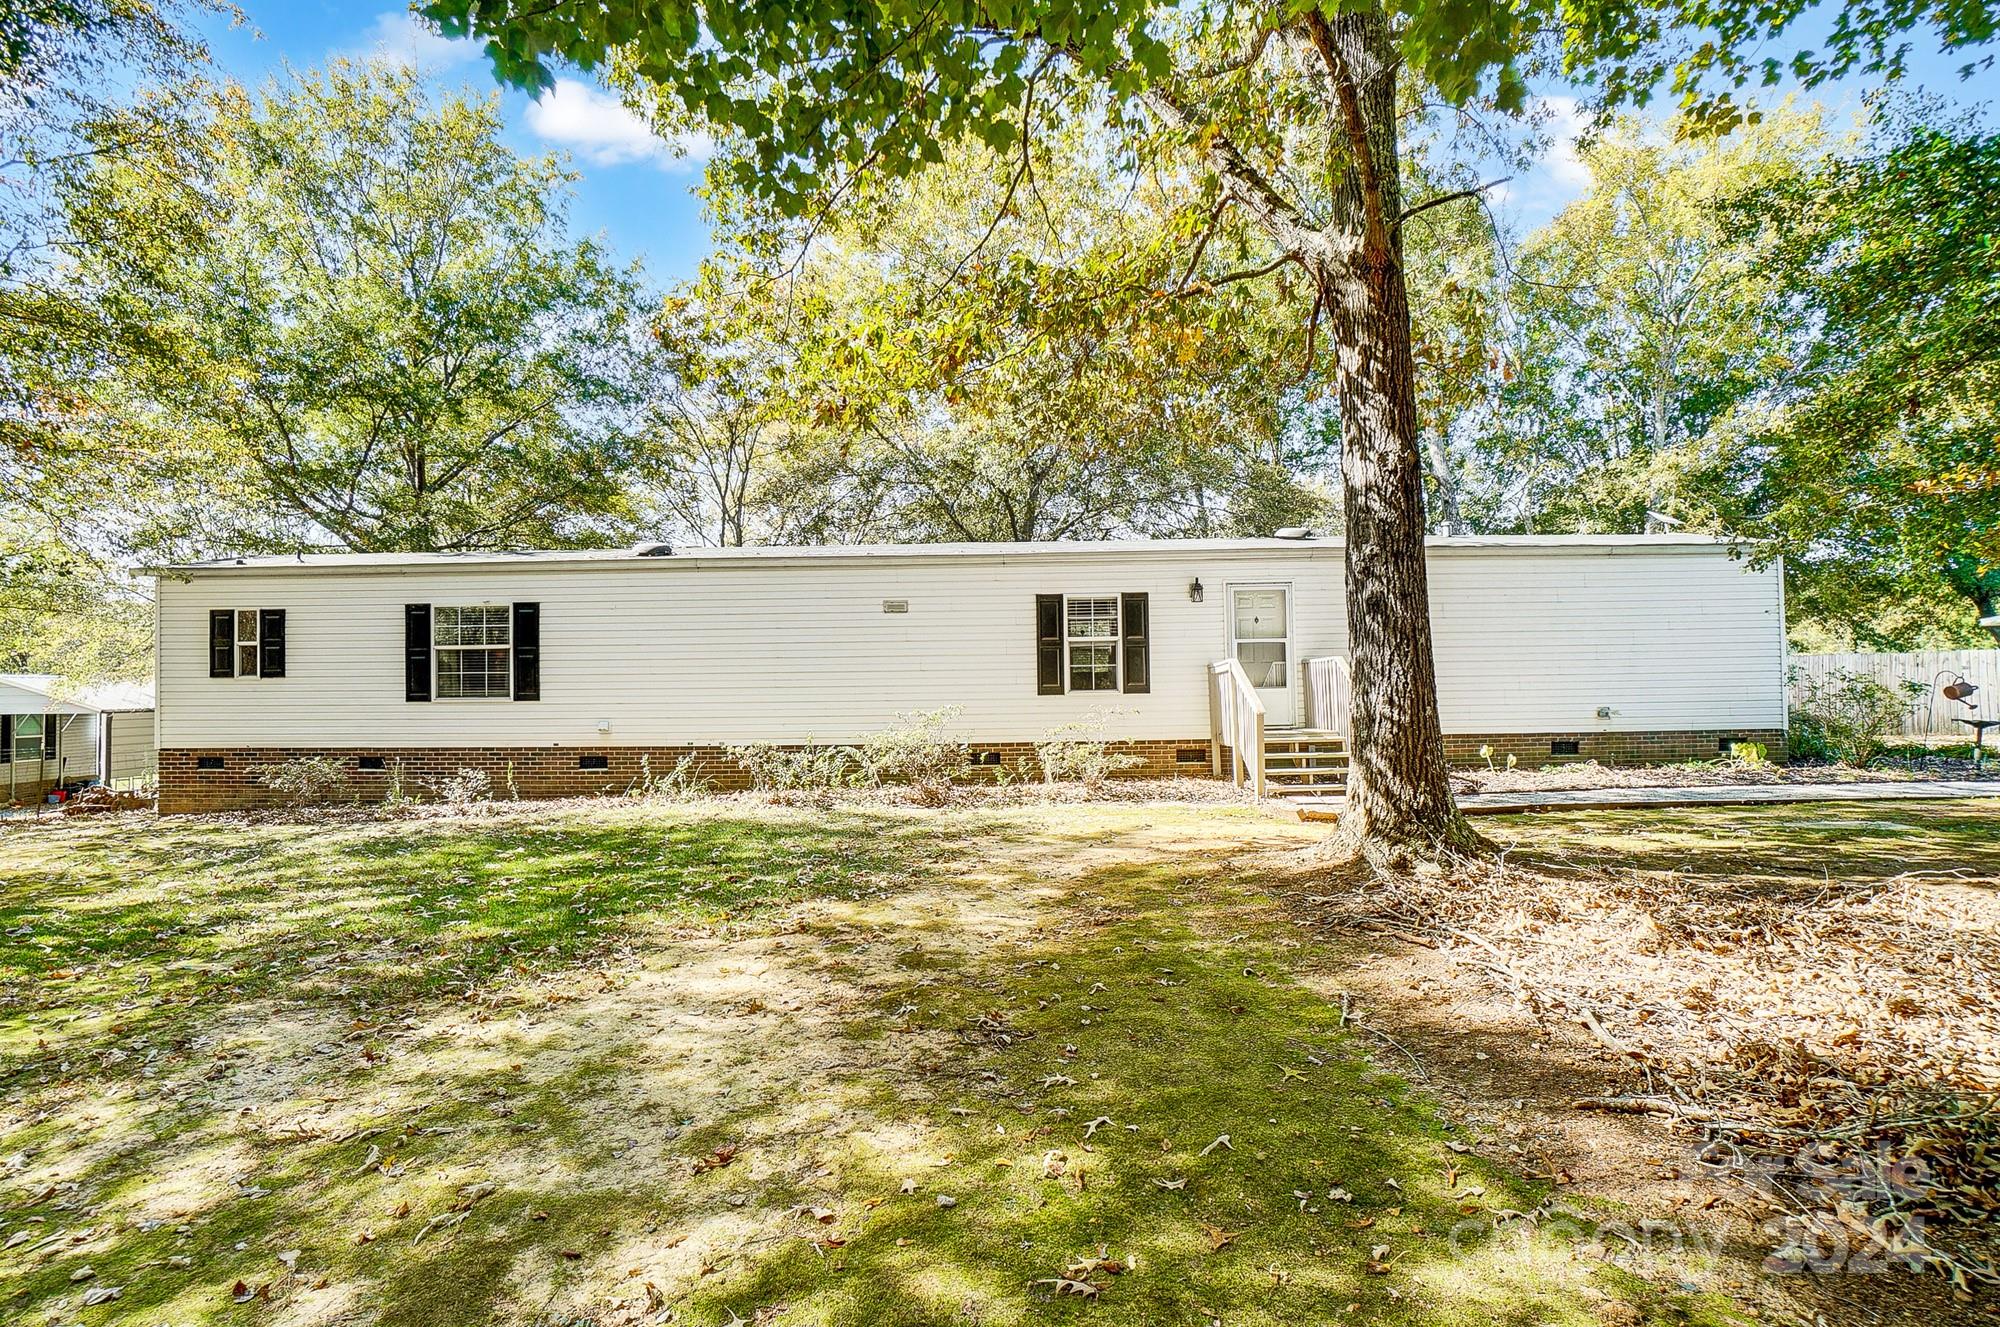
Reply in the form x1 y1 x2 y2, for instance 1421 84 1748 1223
0 799 1960 1327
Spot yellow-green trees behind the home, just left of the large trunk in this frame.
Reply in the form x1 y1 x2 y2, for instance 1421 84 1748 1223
644 126 1338 542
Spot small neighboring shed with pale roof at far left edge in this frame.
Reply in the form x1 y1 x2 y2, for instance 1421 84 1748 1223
0 673 156 801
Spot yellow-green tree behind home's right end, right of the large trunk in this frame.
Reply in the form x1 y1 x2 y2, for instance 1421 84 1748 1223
1456 106 1828 534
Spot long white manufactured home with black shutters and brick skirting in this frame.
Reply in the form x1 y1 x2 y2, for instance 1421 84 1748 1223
154 536 1786 811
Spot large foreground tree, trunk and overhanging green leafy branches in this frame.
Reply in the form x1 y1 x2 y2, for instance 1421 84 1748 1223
424 0 1994 859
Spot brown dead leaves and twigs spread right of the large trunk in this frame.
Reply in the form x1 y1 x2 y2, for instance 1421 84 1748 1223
1300 861 2000 1287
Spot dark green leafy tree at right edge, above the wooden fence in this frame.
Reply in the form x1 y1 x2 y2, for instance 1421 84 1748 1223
1748 118 2000 644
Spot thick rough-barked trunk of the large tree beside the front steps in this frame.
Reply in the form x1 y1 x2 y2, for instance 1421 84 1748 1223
1314 10 1480 863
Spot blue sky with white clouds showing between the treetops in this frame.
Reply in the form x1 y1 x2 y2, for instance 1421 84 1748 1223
204 0 2000 282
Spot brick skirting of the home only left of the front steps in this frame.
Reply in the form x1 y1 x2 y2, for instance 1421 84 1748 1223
160 735 1208 815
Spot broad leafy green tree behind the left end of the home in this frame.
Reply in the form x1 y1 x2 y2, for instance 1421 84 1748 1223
66 62 640 550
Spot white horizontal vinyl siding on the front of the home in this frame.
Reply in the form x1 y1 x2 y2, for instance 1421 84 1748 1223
158 544 1784 747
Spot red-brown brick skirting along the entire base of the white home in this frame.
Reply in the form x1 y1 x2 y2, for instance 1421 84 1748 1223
160 727 1784 813
